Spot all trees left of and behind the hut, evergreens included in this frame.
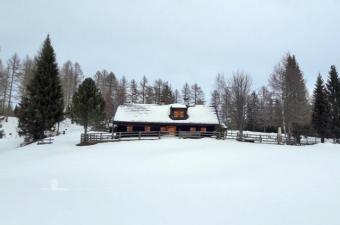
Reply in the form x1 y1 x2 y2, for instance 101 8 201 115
0 36 205 141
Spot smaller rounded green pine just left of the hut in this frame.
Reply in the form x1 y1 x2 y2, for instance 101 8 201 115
72 78 105 134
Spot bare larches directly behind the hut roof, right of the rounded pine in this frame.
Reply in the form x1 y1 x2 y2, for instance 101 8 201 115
94 70 205 125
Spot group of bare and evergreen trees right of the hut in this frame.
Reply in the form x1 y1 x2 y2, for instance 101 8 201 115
211 54 340 144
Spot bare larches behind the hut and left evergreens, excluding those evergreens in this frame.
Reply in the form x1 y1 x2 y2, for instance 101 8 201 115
0 44 206 122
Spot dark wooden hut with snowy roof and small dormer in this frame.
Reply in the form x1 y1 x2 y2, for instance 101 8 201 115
113 104 219 134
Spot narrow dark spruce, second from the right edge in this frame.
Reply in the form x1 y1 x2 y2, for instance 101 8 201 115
312 74 330 143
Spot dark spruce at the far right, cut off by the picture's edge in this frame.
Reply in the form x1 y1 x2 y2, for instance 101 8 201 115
326 66 340 139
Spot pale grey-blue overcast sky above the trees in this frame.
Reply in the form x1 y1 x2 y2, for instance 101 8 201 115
0 0 340 94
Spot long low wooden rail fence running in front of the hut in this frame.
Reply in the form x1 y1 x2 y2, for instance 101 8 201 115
80 131 320 145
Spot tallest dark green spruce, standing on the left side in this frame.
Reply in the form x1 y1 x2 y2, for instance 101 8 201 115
18 36 64 141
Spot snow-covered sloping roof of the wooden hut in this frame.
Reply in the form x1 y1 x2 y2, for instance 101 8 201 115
114 104 219 124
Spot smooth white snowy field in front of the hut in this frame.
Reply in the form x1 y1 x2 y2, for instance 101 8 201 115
0 118 340 225
